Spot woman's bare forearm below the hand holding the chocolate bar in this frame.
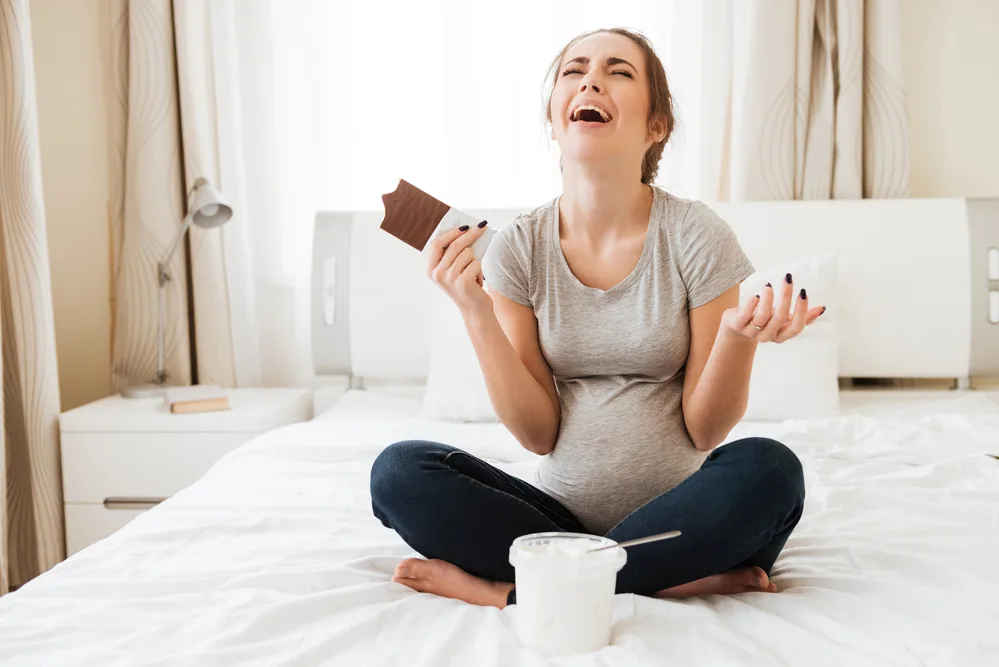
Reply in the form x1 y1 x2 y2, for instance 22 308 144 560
465 311 559 455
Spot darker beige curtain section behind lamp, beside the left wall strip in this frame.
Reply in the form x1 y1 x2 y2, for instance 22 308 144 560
109 0 191 389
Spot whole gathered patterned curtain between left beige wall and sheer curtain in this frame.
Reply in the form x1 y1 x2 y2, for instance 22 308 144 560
109 0 235 389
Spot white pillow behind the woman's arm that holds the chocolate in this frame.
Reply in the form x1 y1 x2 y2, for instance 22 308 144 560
420 287 498 422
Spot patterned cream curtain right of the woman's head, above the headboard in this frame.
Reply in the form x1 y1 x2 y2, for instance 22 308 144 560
701 0 909 200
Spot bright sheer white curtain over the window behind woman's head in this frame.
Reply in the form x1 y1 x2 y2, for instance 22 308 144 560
221 0 701 385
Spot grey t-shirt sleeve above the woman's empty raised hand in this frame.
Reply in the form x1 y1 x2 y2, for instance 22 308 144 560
679 202 754 308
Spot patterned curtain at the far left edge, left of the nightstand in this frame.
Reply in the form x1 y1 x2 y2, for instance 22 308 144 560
0 0 65 593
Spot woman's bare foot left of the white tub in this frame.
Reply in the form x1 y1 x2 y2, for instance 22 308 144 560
392 558 513 609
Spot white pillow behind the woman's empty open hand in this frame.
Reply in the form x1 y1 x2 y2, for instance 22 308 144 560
740 253 839 421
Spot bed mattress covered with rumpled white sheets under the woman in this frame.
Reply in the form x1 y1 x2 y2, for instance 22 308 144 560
0 390 999 667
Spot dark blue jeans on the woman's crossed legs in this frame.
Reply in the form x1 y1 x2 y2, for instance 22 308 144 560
371 438 805 595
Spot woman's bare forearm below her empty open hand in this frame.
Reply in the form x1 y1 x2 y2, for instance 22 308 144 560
683 326 757 451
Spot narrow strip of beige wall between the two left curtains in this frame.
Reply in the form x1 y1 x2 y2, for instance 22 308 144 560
30 0 111 410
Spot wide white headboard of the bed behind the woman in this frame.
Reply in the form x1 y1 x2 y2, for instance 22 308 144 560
312 199 999 381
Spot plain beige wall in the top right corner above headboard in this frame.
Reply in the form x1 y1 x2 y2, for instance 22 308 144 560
902 0 999 197
